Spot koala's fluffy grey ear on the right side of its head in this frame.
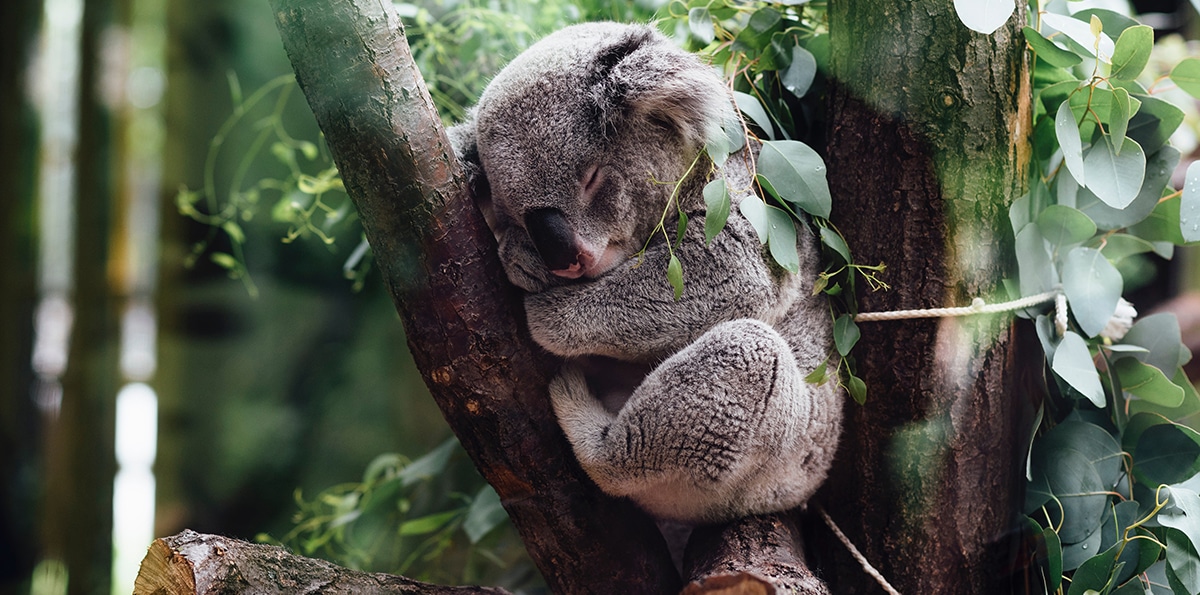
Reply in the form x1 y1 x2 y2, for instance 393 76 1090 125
590 26 732 145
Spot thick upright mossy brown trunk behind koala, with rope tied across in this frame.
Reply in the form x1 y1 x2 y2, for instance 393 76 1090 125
820 0 1033 594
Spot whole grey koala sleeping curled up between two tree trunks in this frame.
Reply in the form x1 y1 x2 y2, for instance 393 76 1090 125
450 23 842 523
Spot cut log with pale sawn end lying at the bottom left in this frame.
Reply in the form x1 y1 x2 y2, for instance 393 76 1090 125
133 530 508 595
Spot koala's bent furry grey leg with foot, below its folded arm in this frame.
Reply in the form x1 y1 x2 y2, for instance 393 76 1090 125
550 319 812 521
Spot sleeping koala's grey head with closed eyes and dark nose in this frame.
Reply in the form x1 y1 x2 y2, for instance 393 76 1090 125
475 23 732 278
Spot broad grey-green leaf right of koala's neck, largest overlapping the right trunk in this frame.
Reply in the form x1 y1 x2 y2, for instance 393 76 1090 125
758 140 833 218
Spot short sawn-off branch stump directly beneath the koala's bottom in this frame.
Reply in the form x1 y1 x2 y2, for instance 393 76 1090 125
683 513 829 595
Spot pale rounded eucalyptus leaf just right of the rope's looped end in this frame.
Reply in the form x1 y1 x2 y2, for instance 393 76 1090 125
1062 247 1123 337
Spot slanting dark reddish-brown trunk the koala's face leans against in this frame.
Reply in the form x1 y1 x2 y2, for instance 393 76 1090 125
271 0 679 593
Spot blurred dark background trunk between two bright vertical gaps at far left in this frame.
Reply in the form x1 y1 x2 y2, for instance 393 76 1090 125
42 0 119 594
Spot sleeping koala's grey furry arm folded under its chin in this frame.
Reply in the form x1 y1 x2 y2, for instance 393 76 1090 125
526 212 779 361
